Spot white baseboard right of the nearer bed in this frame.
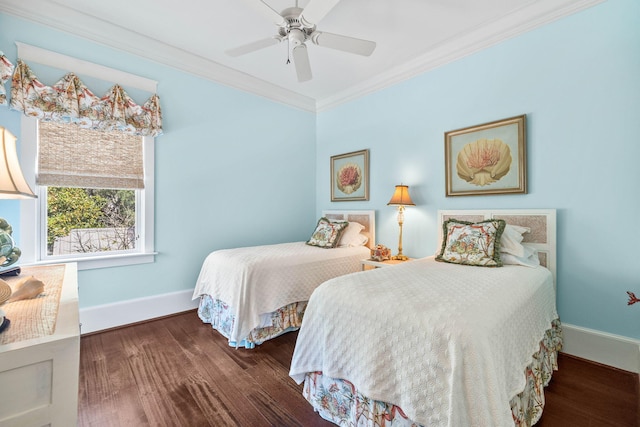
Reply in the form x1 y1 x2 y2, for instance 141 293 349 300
562 323 640 373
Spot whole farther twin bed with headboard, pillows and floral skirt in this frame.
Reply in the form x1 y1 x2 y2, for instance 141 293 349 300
193 210 375 348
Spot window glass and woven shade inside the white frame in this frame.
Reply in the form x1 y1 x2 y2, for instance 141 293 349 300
37 121 144 258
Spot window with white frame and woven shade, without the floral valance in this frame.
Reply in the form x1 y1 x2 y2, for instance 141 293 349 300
20 113 154 270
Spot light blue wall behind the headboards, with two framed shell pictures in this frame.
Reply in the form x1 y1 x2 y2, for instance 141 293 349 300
316 0 640 338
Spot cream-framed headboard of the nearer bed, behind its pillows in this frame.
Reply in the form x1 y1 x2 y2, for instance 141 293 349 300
438 209 556 285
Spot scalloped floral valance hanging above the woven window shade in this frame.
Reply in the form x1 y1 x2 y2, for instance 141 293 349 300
11 59 162 136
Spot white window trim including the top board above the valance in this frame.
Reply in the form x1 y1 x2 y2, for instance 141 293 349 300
16 42 158 270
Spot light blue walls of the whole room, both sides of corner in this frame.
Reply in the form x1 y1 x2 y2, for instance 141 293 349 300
0 0 640 338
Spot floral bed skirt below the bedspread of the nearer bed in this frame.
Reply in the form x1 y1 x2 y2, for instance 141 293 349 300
302 319 562 427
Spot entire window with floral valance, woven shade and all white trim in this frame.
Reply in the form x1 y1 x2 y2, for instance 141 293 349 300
10 43 162 269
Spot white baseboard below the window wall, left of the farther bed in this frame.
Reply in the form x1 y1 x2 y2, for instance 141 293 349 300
80 289 200 334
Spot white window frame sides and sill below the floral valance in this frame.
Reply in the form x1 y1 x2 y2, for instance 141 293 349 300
20 115 157 270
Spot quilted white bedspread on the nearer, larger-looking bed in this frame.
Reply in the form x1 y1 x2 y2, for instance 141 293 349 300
290 257 558 427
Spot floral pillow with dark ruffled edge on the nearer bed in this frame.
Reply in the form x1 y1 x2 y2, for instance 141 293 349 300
436 219 506 267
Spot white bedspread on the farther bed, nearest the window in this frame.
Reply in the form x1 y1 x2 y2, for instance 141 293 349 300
193 242 370 342
